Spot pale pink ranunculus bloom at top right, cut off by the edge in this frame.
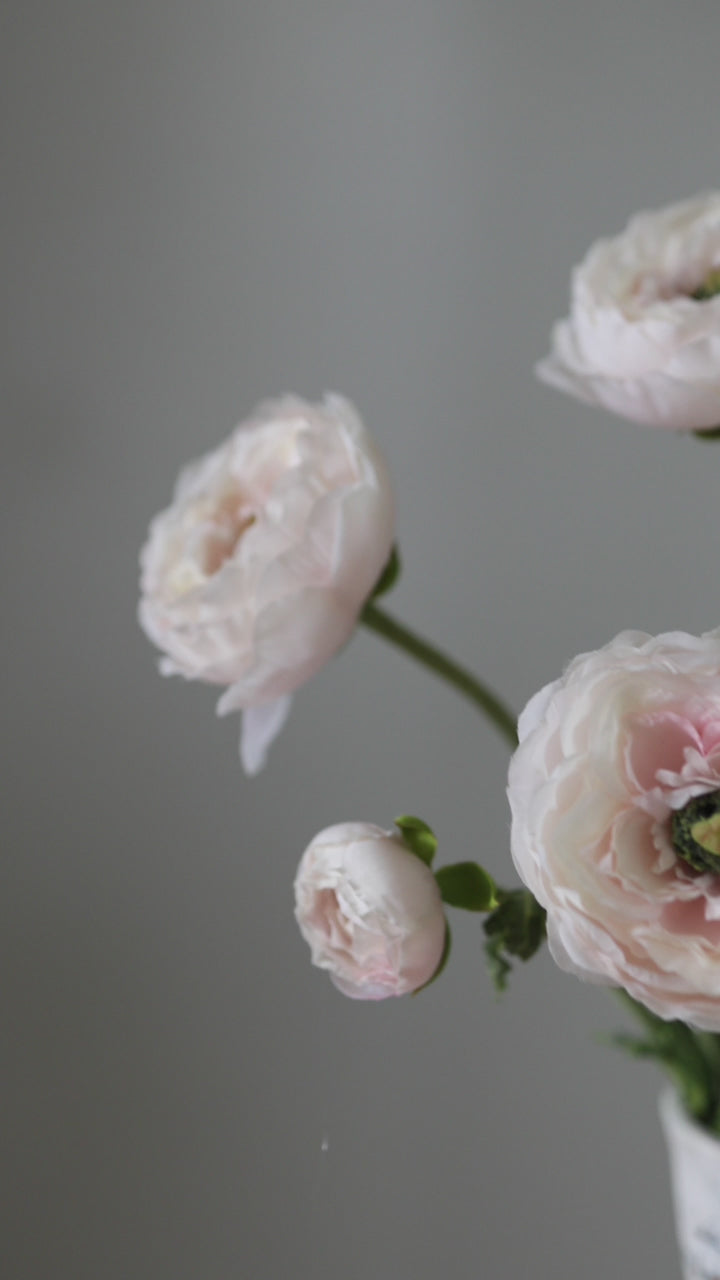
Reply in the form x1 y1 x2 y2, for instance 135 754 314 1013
536 192 720 431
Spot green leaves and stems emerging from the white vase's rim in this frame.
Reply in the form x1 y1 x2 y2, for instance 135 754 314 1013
609 991 720 1133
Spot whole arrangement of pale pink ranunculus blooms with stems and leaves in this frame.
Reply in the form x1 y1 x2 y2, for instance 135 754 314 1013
140 193 720 1280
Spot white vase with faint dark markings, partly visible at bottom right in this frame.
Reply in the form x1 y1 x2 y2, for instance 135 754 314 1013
660 1089 720 1280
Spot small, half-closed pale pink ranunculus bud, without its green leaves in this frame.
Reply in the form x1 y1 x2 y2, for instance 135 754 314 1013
295 822 446 1000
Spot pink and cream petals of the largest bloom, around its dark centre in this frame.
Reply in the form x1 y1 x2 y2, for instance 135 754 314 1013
507 631 720 1032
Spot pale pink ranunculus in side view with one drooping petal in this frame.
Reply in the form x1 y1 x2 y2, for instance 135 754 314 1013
140 396 395 773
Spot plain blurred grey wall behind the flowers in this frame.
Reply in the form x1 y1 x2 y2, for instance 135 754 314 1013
0 0 720 1280
